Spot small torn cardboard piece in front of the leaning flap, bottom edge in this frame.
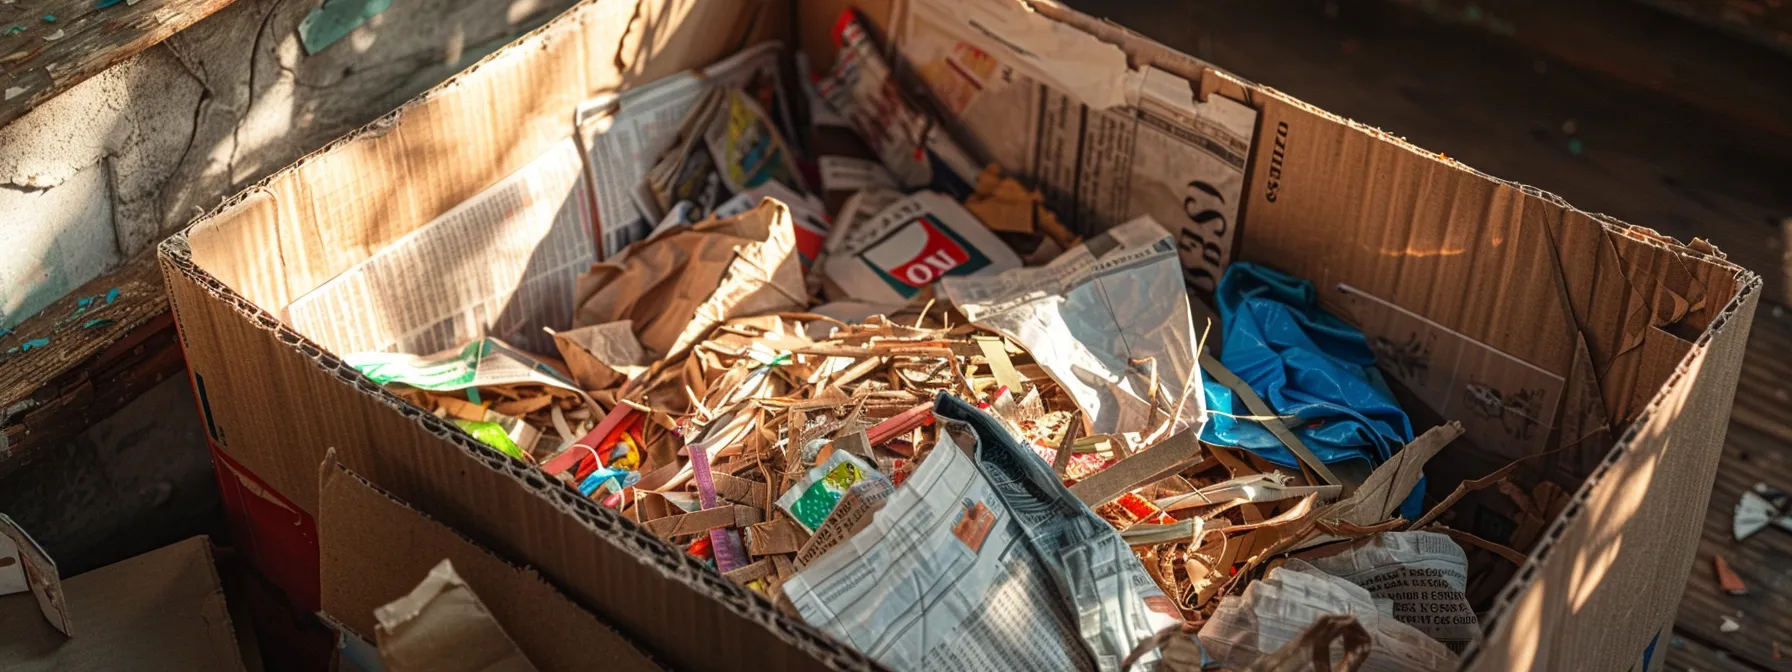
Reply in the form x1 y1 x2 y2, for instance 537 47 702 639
373 559 536 672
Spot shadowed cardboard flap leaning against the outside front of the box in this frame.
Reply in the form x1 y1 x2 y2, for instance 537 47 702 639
317 461 661 670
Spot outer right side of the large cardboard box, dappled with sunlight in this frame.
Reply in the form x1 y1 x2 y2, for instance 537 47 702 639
1464 271 1762 670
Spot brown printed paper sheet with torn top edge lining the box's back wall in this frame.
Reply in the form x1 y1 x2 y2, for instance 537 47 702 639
896 0 1256 292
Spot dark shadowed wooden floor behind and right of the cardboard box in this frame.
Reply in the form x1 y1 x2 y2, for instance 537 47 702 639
1073 0 1792 672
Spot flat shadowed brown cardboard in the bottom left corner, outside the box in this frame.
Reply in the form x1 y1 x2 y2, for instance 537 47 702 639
0 536 250 672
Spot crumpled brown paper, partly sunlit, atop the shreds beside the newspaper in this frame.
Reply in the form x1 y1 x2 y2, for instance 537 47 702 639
573 199 808 358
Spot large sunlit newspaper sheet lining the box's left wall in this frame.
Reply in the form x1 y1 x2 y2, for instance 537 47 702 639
283 138 597 353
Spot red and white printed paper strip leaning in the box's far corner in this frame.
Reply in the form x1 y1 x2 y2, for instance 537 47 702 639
817 9 982 195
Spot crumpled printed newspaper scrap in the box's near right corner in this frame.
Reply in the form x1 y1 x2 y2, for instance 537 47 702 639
1306 532 1480 654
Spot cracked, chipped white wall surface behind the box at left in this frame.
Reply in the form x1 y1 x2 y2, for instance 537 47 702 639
0 0 572 326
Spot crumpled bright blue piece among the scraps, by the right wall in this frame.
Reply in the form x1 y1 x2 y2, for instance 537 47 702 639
1201 262 1425 520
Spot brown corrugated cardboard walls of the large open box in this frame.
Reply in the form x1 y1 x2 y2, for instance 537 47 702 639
161 0 1760 670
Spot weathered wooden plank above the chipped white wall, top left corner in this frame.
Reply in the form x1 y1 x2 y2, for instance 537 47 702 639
0 0 235 125
